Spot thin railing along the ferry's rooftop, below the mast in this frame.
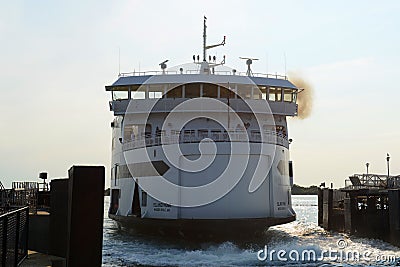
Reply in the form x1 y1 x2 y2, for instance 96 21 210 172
118 69 288 80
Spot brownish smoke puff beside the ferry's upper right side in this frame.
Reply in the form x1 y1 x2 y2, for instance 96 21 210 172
289 73 314 119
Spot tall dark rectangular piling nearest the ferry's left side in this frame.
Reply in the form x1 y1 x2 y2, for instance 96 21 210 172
67 166 105 267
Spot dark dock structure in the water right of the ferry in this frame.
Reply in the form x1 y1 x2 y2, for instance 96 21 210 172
318 174 400 247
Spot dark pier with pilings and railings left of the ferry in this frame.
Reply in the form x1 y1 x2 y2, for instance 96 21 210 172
0 166 105 267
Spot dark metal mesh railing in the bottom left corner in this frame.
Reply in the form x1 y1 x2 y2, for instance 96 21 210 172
0 207 29 266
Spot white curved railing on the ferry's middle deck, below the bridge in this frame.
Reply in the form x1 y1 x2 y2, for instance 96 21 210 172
123 130 289 151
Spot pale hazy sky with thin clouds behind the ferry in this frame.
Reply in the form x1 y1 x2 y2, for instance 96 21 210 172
0 0 400 187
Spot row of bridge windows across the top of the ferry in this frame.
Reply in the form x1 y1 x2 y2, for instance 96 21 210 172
113 83 297 103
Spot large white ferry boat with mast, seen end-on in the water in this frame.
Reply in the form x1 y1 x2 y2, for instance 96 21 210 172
106 18 299 236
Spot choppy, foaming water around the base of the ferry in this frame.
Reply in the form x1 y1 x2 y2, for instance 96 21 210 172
103 196 400 266
